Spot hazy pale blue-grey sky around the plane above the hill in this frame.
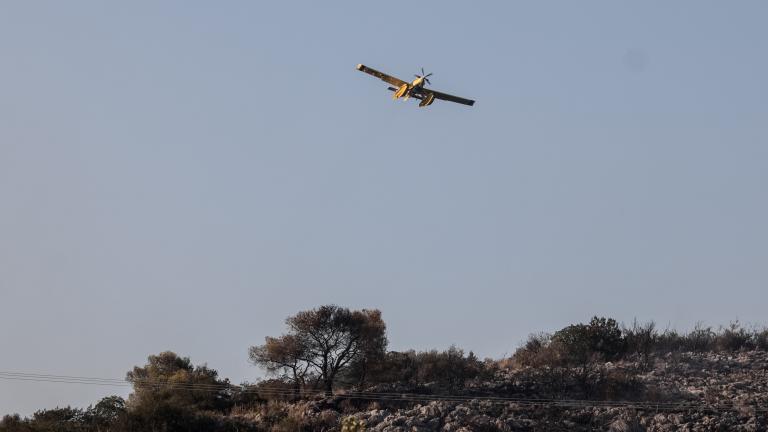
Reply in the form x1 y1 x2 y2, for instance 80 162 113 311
0 0 768 415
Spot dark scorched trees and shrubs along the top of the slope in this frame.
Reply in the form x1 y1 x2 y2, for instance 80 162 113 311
0 305 768 432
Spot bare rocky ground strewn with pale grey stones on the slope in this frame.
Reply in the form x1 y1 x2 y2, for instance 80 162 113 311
266 351 768 432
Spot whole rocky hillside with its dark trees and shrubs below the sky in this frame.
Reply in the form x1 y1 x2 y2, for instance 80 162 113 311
0 306 768 432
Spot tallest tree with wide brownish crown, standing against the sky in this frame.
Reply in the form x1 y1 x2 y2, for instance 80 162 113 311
250 305 387 394
